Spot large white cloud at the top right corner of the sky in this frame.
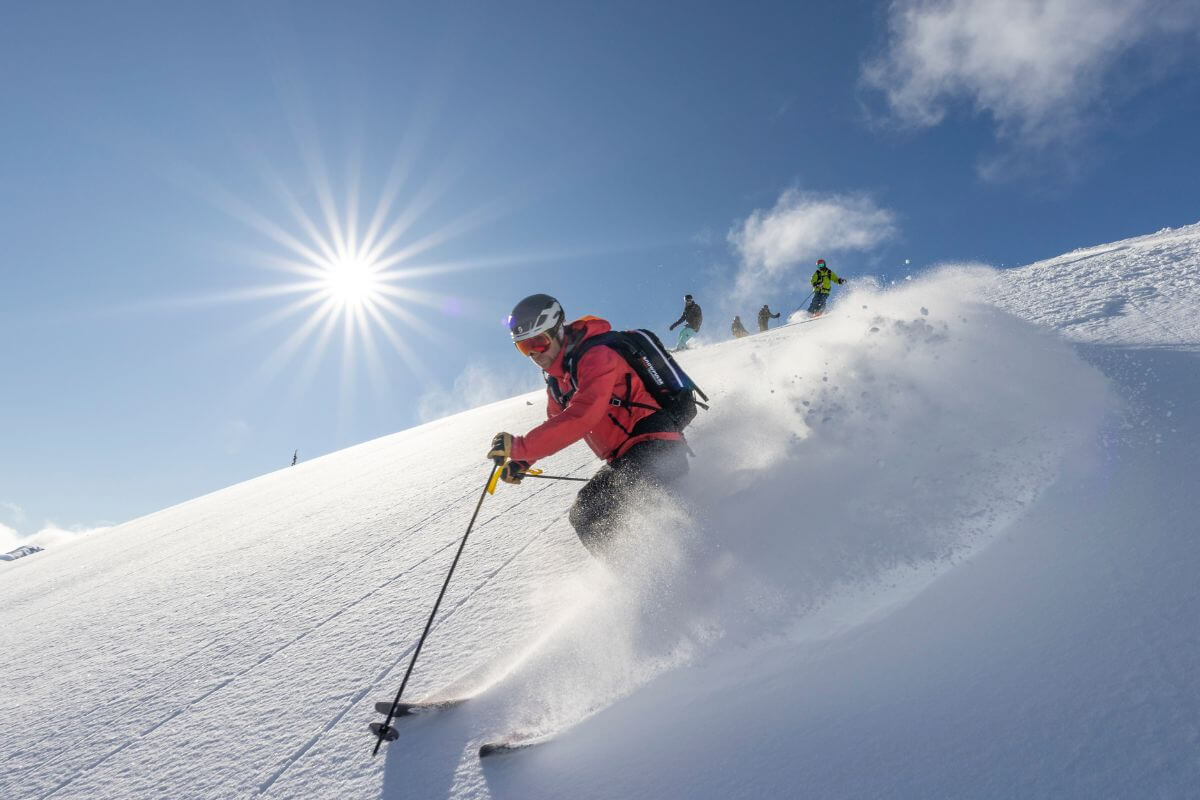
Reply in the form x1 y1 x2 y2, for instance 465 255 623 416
863 0 1200 144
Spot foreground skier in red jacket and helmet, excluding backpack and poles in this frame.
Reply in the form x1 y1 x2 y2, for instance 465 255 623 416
487 294 688 555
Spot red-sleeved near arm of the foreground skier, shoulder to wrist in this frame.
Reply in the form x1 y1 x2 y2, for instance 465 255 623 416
512 347 626 463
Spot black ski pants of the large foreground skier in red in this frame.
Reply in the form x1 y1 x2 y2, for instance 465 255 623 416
570 439 688 557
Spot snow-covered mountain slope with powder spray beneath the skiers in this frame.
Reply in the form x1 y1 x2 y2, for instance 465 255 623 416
0 225 1200 799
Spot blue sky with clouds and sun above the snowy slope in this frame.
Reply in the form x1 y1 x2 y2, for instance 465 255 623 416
0 0 1200 543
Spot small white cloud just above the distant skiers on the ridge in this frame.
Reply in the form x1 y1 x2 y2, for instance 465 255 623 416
728 190 896 297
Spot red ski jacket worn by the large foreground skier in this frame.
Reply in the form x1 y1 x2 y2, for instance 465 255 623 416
512 317 683 464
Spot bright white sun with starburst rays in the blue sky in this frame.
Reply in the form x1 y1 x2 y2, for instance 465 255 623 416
180 131 547 410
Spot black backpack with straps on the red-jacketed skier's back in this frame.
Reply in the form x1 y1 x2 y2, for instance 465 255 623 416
546 329 708 437
